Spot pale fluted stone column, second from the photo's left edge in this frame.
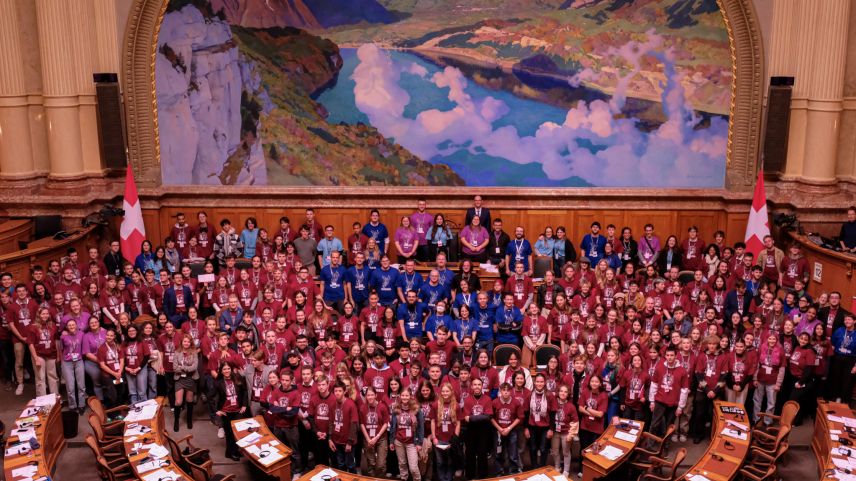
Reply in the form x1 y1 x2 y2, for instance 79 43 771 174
36 0 83 180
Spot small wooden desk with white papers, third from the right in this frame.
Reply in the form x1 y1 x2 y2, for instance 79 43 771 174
583 419 645 481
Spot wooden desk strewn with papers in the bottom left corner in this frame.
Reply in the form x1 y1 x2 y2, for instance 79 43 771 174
3 394 65 481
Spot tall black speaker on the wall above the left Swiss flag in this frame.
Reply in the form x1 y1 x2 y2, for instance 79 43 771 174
93 73 127 172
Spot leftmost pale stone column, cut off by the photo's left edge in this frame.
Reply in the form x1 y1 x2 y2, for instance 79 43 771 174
0 0 36 179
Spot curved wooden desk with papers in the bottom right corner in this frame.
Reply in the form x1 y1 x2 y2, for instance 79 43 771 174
811 401 856 481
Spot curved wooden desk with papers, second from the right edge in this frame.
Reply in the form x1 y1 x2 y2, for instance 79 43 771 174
682 401 752 481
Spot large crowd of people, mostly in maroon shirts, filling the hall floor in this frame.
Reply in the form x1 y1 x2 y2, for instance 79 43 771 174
0 197 856 481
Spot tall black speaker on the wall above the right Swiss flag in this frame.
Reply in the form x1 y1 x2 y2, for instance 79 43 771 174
763 77 794 174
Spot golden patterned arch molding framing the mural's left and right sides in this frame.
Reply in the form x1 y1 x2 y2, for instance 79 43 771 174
122 0 764 191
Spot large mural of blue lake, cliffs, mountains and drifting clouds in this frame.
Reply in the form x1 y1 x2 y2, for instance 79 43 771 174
156 0 732 187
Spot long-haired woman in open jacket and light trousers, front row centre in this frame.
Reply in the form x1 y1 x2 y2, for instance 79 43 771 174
389 389 425 481
